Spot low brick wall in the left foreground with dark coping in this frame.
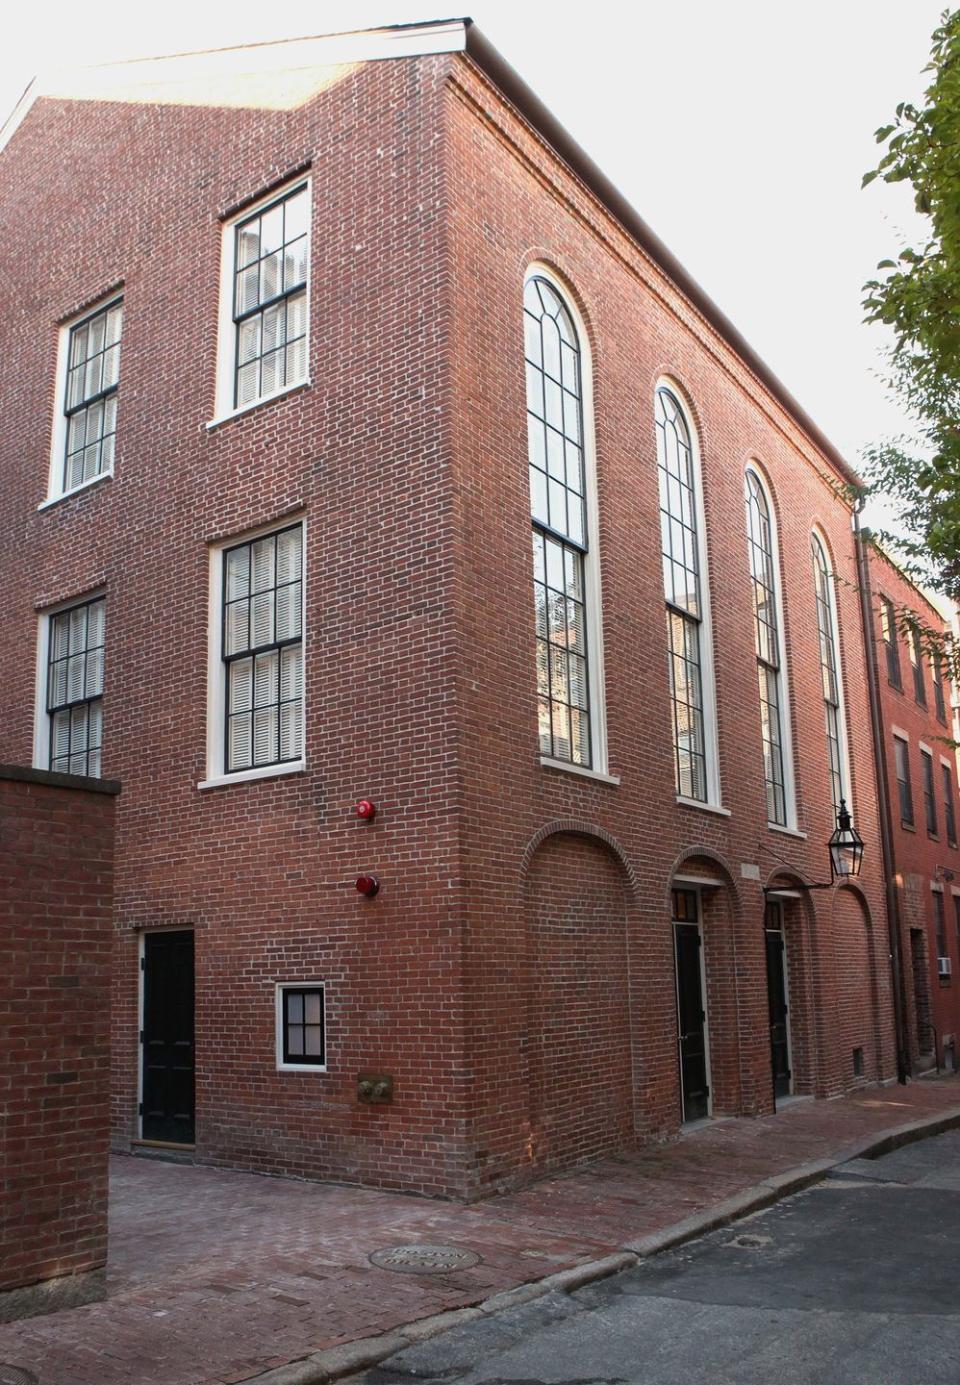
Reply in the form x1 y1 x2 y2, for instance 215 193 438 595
0 765 119 1321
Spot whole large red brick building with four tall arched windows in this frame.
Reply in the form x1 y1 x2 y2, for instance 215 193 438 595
0 22 894 1197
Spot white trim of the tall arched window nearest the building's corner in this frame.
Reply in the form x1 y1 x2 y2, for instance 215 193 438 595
521 263 606 783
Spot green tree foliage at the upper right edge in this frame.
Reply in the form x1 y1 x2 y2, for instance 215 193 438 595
863 10 960 600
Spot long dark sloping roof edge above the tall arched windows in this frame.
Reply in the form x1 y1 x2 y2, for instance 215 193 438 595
465 19 863 488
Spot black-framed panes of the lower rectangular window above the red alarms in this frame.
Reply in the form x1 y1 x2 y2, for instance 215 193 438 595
222 524 303 774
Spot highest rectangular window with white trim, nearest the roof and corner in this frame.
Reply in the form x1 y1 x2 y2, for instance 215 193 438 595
217 181 310 417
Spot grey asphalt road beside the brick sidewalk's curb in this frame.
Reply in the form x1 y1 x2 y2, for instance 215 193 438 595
363 1133 960 1385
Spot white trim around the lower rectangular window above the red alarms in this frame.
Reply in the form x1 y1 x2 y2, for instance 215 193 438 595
197 511 308 792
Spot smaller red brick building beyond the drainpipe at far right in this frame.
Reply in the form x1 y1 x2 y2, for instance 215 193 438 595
870 548 960 1072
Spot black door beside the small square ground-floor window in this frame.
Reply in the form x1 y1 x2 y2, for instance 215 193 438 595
140 931 194 1144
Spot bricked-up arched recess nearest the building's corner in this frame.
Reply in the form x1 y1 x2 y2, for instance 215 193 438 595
521 820 636 1173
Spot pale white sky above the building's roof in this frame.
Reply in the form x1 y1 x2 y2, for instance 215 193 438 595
0 0 943 476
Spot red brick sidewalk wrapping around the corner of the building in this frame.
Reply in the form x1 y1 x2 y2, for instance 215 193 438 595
0 1078 960 1385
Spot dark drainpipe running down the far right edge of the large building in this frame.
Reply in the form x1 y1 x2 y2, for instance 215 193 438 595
853 496 910 1084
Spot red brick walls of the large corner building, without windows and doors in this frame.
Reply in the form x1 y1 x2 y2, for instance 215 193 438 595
0 27 894 1197
